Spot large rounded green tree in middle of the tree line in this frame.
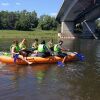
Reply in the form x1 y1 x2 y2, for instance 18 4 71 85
15 10 38 31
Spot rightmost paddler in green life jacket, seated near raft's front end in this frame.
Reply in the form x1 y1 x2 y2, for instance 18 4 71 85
54 40 67 63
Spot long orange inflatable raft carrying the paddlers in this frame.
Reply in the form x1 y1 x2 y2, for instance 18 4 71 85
0 53 77 65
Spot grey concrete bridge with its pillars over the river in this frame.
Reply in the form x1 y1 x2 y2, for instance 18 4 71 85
56 0 100 37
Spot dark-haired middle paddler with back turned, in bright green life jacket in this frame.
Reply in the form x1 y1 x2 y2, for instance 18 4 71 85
38 40 51 57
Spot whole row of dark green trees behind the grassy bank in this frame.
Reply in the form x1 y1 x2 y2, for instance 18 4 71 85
0 10 58 31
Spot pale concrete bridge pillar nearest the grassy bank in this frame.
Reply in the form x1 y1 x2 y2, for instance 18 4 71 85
61 21 74 37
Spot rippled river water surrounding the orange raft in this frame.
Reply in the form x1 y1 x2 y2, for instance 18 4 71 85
0 39 100 100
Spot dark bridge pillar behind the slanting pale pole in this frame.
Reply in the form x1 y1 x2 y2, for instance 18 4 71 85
82 21 96 37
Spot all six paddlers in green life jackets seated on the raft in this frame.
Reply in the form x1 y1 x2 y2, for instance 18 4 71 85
10 39 67 64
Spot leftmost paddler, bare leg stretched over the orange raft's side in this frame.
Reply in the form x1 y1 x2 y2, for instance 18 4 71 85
10 40 32 64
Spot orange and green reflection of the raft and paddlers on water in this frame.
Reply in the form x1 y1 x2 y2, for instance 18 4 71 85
1 64 50 85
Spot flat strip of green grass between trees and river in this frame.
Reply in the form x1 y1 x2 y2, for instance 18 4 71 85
0 30 57 38
